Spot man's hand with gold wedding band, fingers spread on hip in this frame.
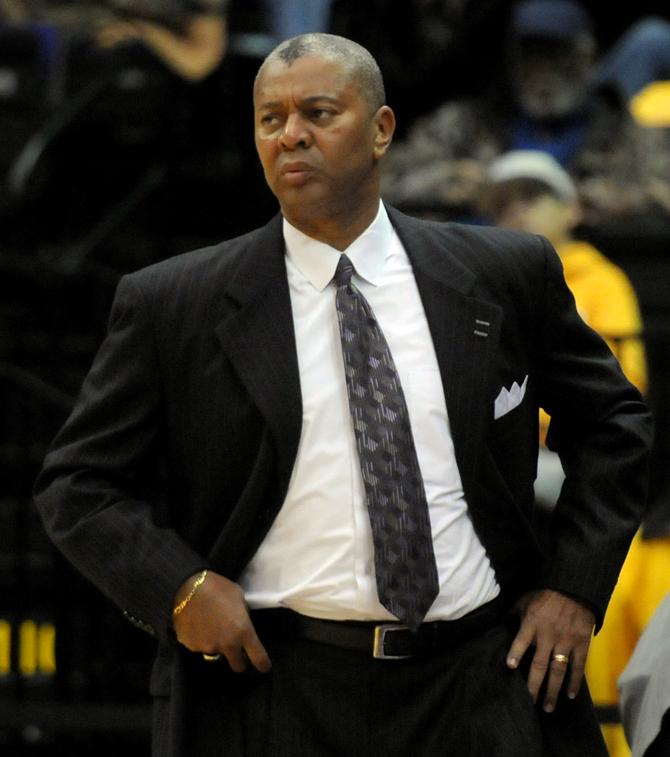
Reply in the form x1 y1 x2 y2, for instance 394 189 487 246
507 589 595 712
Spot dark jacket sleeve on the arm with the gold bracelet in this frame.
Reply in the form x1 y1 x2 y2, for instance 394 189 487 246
34 277 206 640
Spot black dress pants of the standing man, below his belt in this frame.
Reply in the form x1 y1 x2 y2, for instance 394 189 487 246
177 625 607 757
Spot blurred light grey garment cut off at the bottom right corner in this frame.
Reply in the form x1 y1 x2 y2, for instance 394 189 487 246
619 594 670 757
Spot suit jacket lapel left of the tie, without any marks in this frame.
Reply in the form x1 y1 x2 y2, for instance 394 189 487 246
215 216 302 491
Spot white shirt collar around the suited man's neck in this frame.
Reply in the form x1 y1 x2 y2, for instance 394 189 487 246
283 201 393 292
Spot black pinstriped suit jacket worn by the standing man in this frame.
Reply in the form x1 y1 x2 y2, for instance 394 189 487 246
36 204 650 753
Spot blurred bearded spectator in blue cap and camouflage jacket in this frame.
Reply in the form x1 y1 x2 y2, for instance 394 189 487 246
384 0 668 224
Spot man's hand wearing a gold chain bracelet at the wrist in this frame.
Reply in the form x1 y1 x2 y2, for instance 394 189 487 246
173 571 272 673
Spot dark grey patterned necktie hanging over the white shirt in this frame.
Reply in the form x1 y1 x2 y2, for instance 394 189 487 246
335 255 439 630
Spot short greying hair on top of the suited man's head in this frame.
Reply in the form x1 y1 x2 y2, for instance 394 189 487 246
256 33 386 110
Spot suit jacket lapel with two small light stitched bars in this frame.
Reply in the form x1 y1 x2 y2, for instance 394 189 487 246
389 209 502 496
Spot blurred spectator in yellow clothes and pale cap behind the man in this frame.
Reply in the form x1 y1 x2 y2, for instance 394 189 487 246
481 150 670 757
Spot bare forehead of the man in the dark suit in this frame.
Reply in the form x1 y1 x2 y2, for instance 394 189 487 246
254 55 359 108
